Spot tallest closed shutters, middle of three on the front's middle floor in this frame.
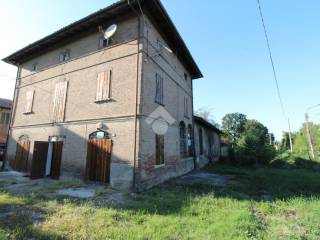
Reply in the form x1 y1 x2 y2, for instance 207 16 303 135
52 81 68 122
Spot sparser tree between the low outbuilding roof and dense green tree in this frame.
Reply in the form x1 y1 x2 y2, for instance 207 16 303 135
222 113 247 147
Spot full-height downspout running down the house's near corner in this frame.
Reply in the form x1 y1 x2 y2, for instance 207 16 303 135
128 0 141 192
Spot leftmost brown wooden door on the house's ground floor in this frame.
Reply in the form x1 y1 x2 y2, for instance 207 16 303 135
10 141 30 172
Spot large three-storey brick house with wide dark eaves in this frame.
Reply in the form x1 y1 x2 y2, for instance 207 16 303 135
4 0 221 190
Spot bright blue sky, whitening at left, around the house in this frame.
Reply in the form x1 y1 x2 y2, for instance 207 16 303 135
0 0 320 139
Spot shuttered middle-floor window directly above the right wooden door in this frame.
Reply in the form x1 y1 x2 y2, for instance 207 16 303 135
96 70 112 102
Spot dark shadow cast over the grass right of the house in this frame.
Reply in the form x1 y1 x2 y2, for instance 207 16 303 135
0 164 320 220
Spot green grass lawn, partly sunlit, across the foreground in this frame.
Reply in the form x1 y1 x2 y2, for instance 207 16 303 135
0 165 320 240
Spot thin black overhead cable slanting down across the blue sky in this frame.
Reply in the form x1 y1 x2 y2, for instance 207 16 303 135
257 0 287 118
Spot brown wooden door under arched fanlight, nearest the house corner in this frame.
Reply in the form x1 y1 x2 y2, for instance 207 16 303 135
86 139 112 183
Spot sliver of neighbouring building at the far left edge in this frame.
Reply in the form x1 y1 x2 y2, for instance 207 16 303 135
0 98 12 144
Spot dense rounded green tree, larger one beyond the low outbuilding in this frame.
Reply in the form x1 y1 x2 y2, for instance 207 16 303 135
235 120 275 164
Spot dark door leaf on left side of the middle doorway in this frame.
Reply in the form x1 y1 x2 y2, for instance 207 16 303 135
30 142 49 179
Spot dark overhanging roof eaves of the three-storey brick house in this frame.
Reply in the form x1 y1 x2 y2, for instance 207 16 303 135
3 0 202 79
